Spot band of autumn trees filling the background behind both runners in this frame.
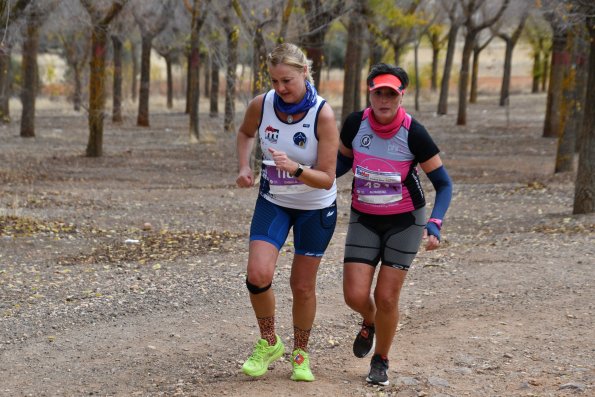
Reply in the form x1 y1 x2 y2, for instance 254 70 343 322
0 0 594 213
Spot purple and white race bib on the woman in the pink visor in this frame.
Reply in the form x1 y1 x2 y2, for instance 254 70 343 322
354 166 403 204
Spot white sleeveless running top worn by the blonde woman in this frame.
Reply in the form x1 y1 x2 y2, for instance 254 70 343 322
258 90 337 210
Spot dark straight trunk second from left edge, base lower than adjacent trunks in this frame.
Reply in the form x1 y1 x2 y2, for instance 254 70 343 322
21 16 39 138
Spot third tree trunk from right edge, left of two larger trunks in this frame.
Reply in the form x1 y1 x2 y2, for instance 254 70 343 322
543 32 570 138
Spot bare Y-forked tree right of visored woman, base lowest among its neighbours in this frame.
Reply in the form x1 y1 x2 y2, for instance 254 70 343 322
457 0 510 125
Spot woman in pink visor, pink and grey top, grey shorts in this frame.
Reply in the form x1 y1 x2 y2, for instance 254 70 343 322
337 64 452 385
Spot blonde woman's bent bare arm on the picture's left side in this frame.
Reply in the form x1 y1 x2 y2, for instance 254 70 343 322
236 95 264 187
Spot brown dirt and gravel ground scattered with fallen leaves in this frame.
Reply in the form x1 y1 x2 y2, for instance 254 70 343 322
0 96 595 397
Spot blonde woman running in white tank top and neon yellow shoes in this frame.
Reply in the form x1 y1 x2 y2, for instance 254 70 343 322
236 43 339 381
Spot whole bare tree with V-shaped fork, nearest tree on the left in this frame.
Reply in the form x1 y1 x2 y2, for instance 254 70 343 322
81 0 128 157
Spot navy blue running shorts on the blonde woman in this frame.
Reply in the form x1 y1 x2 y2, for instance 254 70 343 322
250 196 337 256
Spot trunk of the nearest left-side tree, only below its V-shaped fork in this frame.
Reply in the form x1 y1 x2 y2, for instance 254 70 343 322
87 30 107 157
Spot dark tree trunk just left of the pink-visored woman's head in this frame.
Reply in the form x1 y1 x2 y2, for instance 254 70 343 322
341 4 363 124
